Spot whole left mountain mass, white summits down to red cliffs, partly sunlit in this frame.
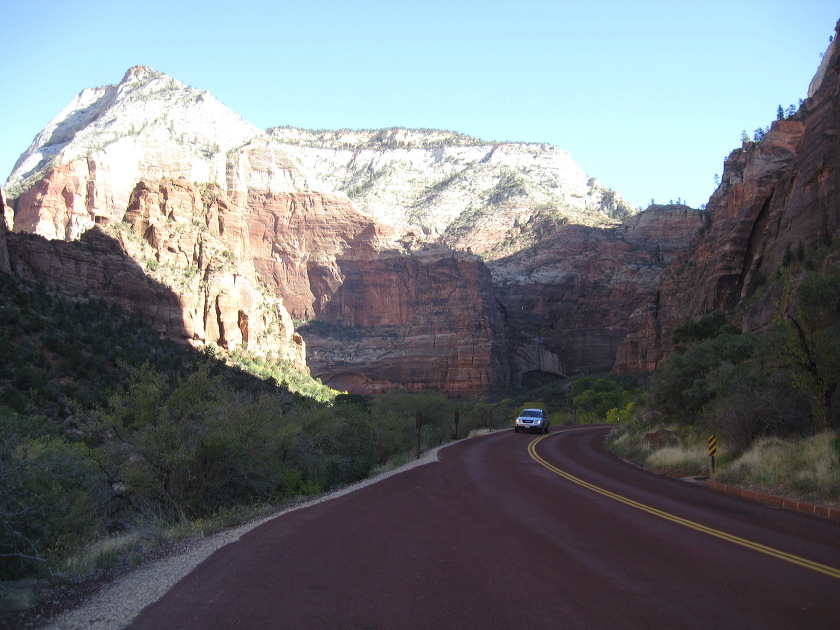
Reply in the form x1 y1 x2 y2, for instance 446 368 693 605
7 66 635 392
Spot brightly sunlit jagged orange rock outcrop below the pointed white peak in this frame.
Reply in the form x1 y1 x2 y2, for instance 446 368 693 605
124 179 305 369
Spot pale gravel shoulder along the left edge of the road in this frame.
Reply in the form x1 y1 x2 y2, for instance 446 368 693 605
24 445 446 630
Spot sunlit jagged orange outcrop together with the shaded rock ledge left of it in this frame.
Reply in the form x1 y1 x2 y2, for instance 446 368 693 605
8 175 307 370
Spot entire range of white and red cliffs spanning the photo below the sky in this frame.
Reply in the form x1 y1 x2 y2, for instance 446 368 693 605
0 19 840 393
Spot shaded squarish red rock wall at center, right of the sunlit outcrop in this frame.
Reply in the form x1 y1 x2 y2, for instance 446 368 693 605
301 248 509 393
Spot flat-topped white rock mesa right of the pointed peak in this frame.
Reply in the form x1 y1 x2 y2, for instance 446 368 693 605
268 127 638 259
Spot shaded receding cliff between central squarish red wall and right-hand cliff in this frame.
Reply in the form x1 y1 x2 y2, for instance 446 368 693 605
490 206 705 385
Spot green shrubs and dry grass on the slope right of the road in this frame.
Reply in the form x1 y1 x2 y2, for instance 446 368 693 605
608 257 840 502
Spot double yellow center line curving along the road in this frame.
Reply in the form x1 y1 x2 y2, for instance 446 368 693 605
528 429 840 578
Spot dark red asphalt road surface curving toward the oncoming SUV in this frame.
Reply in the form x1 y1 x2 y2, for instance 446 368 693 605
123 427 840 630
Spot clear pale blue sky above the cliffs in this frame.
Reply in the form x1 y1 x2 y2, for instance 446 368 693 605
0 0 840 207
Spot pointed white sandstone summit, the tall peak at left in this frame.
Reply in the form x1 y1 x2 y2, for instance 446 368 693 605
6 66 261 197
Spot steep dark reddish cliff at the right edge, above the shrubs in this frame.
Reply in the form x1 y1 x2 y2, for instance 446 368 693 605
617 22 840 370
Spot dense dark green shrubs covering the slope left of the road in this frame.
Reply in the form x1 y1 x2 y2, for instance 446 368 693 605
0 274 507 596
